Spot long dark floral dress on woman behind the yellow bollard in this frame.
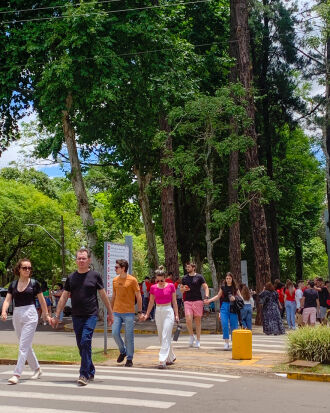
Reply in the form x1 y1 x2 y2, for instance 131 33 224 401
259 290 285 335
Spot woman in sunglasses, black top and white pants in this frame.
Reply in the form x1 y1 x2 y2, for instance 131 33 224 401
1 258 50 384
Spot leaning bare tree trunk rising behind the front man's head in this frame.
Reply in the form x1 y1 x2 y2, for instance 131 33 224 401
62 94 103 275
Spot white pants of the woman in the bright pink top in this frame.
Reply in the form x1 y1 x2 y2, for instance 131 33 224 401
155 304 175 364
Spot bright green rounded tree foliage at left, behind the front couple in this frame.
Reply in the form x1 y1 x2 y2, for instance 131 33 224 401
0 178 82 280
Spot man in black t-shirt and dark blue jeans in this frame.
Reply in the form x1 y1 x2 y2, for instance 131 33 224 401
52 248 113 386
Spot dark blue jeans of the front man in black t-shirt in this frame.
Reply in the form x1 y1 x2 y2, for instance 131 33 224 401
72 315 97 379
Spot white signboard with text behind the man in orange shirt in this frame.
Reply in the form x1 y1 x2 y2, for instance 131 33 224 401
104 242 129 297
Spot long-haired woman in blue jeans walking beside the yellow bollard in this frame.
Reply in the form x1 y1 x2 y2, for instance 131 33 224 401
204 272 241 350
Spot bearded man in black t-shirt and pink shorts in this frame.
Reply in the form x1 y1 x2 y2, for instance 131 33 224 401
180 262 209 348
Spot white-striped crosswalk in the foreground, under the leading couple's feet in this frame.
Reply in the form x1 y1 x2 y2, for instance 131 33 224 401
0 365 240 413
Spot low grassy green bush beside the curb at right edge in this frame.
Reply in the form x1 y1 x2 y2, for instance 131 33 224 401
288 326 330 363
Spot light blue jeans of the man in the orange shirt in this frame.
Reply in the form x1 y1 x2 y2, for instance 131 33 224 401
112 313 135 360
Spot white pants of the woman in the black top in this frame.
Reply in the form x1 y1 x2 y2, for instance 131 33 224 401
13 305 39 376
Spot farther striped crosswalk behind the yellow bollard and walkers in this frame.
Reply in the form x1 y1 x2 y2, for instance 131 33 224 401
147 335 287 354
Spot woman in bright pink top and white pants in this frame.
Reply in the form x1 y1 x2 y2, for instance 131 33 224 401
144 266 179 369
